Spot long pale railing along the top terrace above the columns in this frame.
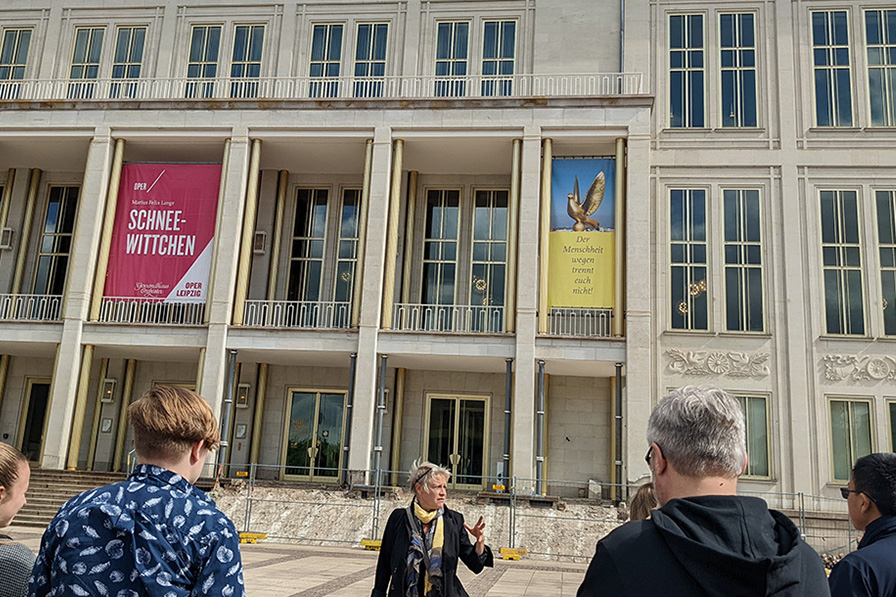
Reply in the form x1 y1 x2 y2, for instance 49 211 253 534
0 73 643 102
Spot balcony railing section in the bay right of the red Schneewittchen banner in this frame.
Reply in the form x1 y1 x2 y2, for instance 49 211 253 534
243 301 352 329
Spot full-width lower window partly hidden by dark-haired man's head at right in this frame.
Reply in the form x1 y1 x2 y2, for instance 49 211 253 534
831 399 871 482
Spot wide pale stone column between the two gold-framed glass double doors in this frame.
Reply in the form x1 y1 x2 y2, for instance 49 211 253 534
347 127 392 480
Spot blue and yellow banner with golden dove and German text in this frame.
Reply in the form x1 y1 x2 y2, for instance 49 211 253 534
548 158 616 309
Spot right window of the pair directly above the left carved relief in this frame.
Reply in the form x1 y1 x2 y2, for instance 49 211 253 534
722 189 764 332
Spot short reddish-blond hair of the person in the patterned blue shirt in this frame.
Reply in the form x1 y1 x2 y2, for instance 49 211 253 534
128 386 221 460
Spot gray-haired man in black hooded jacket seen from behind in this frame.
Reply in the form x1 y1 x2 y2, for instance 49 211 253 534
578 386 830 597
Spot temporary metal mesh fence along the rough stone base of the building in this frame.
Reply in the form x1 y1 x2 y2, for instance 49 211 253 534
215 464 856 561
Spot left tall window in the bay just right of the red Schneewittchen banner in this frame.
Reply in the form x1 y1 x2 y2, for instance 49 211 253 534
286 189 329 302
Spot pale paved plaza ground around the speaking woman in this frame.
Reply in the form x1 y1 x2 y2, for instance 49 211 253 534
7 526 587 597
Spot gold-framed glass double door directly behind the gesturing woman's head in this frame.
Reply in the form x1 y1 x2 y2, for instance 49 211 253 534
426 395 488 489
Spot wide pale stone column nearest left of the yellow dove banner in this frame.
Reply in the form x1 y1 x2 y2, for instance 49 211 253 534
508 127 541 491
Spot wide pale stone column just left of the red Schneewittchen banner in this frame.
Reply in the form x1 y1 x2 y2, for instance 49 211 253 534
41 130 114 469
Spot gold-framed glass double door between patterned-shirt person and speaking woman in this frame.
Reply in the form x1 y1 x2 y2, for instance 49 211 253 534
284 391 346 481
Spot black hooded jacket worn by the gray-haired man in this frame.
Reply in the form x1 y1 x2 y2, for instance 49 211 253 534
578 496 830 597
